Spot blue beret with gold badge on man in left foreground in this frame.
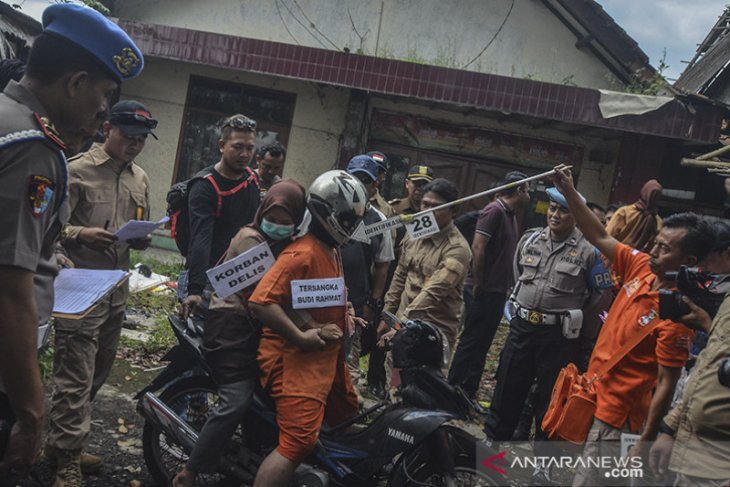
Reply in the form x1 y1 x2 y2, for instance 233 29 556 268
43 3 144 82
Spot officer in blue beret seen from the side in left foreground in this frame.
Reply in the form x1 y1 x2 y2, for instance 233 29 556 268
0 4 144 487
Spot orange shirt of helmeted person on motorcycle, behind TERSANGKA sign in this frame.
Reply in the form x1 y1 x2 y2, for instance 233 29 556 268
248 234 346 403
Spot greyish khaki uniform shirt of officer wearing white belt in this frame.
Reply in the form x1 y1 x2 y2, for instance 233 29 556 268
512 227 597 313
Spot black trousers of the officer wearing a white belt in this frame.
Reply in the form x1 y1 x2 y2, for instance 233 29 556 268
484 316 578 453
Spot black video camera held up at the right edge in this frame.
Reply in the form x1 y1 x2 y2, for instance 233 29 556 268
659 266 725 321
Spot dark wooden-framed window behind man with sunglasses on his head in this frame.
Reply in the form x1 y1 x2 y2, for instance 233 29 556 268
173 76 296 182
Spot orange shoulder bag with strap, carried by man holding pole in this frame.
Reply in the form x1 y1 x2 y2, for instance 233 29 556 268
541 320 662 445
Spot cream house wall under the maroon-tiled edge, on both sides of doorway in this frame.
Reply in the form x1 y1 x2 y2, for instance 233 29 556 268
122 58 620 218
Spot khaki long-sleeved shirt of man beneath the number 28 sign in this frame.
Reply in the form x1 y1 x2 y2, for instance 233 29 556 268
385 223 471 350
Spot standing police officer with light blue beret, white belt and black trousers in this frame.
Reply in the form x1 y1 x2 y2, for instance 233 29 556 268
484 188 611 485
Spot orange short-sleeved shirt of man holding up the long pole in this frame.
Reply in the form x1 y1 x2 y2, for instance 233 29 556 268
588 244 693 431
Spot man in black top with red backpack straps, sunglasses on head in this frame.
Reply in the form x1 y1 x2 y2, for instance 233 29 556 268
182 114 260 317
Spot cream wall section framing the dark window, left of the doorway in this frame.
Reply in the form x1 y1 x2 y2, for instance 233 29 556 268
121 58 349 218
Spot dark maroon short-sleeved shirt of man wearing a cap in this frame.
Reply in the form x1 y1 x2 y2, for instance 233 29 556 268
467 198 520 293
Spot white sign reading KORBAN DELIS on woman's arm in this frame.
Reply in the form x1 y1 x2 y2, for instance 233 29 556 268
205 242 275 298
